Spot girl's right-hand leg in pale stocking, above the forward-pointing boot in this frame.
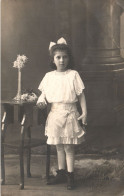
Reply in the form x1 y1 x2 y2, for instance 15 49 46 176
64 144 75 172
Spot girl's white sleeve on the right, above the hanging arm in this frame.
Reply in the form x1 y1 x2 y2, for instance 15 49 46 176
74 71 85 96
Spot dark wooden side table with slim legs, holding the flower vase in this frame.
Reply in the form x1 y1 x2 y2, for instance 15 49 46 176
1 101 50 189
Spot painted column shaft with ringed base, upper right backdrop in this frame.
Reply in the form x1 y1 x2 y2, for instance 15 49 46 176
83 0 124 71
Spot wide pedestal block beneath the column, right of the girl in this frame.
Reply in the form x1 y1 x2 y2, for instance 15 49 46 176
79 63 124 126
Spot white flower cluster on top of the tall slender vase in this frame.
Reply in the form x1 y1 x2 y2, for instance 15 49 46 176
13 55 28 69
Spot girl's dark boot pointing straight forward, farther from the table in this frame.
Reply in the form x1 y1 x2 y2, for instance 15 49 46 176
67 172 74 190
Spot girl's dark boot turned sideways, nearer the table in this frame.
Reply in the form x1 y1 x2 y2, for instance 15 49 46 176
47 169 66 185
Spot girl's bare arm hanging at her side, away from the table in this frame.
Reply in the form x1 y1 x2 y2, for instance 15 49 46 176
78 92 87 125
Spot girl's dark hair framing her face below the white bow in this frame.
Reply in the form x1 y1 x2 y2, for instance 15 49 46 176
50 44 74 70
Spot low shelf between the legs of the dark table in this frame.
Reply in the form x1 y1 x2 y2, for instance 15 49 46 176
3 138 46 149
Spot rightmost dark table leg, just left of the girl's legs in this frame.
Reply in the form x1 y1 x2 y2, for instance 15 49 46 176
46 144 51 181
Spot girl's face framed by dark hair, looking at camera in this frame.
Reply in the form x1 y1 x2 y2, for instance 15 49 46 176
53 50 69 72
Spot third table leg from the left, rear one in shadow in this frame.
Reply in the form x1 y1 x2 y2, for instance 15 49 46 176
27 127 31 178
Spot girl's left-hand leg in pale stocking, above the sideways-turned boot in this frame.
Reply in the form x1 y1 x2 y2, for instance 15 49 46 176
56 144 66 170
